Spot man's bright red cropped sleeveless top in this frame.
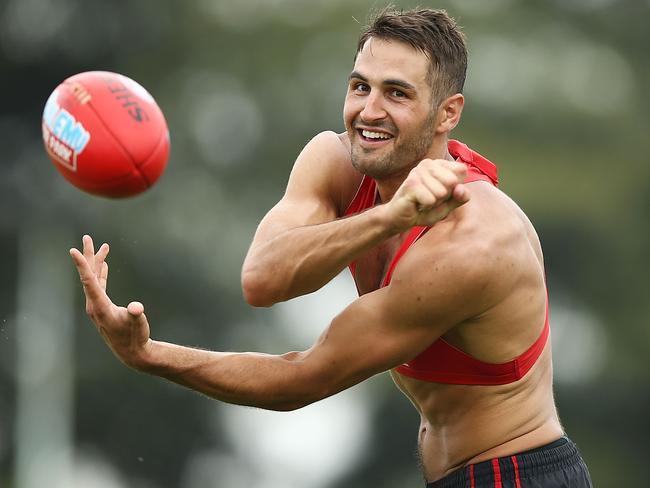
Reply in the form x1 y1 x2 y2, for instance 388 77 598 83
345 139 550 385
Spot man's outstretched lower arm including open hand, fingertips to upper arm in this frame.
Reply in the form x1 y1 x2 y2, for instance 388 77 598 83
71 233 485 410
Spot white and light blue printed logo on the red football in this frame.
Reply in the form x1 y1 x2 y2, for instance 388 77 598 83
42 88 90 171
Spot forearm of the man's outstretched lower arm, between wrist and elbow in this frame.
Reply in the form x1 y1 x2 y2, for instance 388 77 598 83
139 341 324 410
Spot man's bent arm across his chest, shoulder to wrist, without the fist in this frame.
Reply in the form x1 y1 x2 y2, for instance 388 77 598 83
242 132 392 306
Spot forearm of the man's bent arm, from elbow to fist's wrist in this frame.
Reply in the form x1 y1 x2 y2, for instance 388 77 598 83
242 206 396 306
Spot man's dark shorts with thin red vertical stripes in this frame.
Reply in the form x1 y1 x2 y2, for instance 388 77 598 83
427 437 592 488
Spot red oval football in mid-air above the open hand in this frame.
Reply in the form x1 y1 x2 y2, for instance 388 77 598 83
42 71 169 198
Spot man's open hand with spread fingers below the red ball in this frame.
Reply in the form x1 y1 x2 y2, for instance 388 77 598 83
70 235 151 369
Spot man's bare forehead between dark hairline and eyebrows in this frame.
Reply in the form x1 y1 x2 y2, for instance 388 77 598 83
354 37 430 86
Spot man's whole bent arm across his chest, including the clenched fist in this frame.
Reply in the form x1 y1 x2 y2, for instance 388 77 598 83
242 132 469 306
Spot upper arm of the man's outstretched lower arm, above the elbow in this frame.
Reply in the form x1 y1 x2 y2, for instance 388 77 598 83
294 242 492 395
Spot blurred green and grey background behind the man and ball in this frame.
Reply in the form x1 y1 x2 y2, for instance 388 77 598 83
0 0 650 488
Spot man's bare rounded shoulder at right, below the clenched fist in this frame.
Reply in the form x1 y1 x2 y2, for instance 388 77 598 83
392 183 543 323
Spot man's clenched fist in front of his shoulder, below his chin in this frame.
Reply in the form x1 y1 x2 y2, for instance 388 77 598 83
386 159 470 232
